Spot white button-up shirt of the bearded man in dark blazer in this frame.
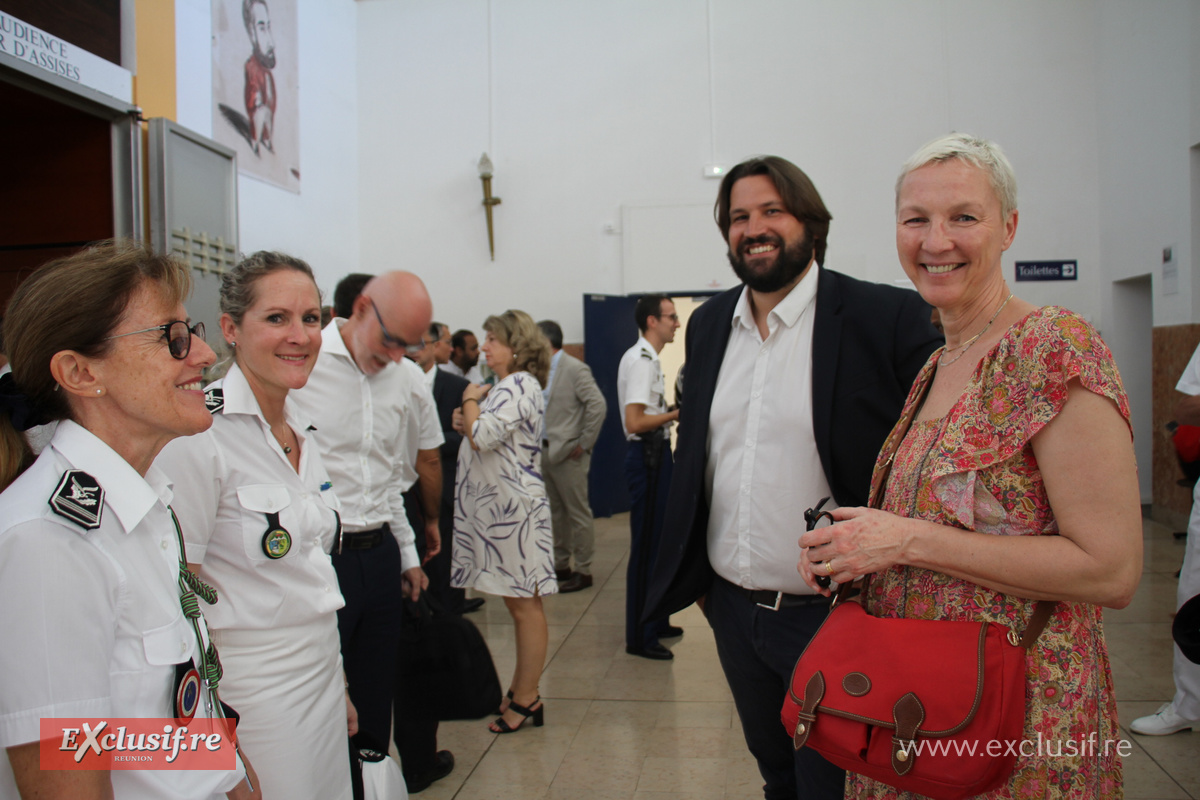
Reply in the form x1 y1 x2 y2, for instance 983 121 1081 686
704 264 836 595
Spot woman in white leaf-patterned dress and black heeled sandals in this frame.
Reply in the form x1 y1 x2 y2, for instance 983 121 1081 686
451 311 558 733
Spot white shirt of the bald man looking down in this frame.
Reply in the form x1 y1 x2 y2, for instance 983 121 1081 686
286 318 421 568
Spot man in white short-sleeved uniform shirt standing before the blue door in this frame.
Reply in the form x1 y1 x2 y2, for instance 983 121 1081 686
617 294 683 661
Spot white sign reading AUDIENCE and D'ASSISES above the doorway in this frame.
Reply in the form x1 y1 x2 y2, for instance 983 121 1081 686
0 11 133 103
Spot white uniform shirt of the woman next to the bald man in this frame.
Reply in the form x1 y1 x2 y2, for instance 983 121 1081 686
155 365 346 633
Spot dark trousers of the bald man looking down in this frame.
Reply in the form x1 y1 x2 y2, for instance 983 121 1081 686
332 530 402 742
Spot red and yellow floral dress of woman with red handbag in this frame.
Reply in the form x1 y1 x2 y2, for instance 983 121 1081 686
846 306 1129 800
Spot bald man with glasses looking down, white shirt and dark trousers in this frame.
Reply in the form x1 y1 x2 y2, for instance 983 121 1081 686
292 272 442 767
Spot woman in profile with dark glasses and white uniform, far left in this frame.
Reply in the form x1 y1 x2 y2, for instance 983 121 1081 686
0 242 259 799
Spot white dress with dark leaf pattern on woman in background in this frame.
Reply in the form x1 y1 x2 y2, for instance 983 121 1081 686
450 372 558 597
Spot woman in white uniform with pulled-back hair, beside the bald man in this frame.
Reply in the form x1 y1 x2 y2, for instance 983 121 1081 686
157 252 356 800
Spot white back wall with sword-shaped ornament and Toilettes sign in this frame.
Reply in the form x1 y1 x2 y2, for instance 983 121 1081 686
358 0 1198 341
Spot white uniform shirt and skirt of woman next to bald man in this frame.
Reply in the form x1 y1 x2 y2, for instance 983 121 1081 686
155 363 350 800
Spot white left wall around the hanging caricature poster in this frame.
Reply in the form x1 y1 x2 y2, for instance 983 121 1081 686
175 0 359 295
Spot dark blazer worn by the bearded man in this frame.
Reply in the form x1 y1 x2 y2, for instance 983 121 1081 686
646 269 942 619
